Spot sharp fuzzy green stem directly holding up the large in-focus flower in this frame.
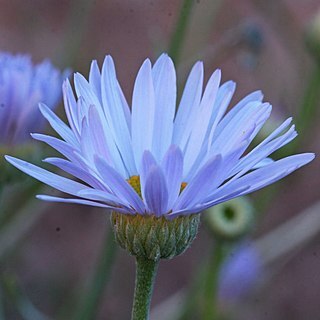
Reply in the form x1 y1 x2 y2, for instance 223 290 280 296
131 258 159 320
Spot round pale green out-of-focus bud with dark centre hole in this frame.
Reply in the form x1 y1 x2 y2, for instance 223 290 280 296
203 197 254 241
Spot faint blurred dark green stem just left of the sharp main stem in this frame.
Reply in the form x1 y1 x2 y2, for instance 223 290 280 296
74 228 117 320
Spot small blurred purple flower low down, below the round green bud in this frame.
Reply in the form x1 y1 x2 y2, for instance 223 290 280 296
218 244 263 301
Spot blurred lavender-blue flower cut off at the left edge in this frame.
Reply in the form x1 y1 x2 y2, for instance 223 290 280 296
0 53 66 145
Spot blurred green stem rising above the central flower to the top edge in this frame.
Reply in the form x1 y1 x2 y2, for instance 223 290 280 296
169 0 195 64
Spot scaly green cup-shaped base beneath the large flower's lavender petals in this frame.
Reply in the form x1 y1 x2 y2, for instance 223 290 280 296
111 211 200 261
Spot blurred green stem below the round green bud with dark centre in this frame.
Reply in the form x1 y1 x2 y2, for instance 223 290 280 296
202 242 224 320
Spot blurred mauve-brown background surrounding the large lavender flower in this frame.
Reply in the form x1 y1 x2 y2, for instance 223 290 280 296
0 0 320 320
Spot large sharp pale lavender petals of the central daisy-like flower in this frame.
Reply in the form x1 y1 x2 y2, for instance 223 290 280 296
6 54 314 218
